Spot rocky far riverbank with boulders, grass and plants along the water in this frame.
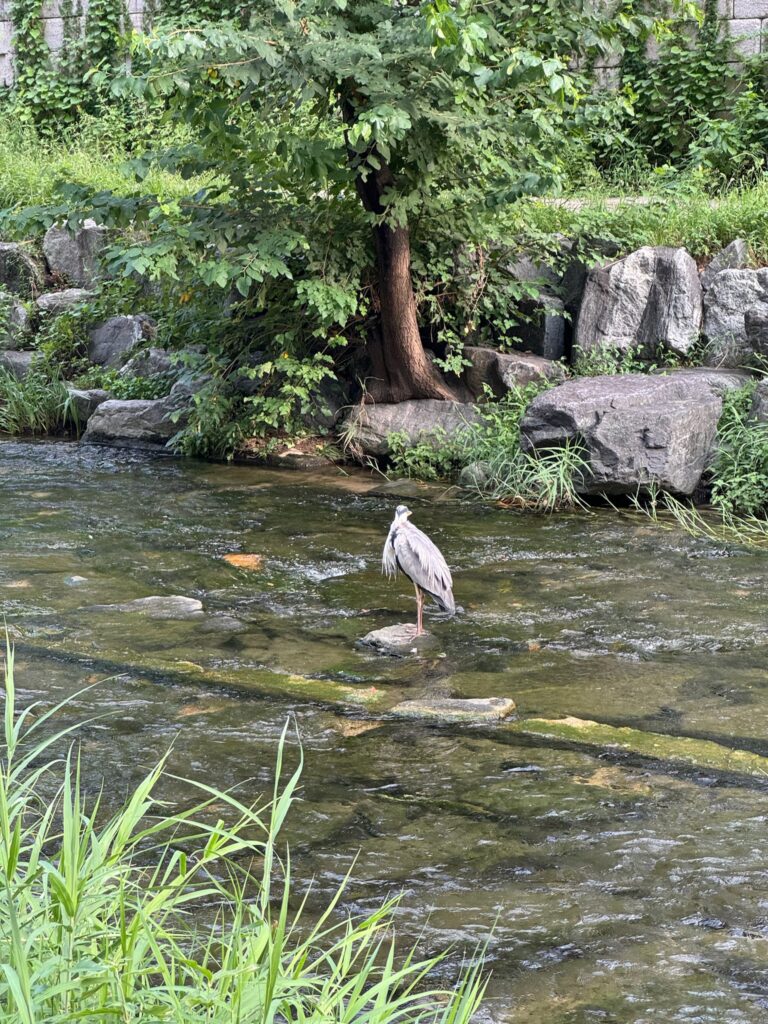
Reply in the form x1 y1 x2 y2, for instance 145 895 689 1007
0 222 768 536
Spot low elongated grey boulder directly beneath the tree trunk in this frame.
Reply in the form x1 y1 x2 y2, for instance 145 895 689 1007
342 398 480 456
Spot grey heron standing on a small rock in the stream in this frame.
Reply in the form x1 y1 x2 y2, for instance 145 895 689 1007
381 505 456 636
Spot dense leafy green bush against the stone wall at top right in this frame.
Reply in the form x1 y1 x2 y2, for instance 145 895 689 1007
571 0 768 187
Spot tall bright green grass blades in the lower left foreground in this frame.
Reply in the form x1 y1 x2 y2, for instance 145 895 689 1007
0 649 483 1024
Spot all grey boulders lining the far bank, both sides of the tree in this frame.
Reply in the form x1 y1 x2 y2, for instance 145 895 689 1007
0 221 768 503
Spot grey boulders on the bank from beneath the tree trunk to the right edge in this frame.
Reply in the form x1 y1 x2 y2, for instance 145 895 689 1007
343 240 768 496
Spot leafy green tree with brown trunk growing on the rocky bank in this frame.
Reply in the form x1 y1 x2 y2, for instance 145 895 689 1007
22 0 671 411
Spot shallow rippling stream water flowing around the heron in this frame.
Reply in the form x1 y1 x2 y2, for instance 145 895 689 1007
0 441 768 1024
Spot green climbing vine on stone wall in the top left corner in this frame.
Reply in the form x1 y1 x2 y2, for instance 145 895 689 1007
10 0 128 126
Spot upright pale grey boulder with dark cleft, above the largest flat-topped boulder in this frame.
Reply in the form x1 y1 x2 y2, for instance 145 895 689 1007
575 246 701 354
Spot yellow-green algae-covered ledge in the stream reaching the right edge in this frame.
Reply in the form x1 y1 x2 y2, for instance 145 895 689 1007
507 716 768 781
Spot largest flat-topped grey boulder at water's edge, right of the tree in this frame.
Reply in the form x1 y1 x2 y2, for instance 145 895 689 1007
520 374 722 495
